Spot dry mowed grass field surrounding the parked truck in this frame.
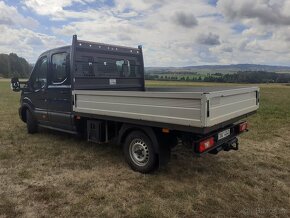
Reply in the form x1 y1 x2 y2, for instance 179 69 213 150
0 81 290 217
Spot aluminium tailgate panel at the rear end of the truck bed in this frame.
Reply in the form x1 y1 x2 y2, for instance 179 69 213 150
205 87 259 127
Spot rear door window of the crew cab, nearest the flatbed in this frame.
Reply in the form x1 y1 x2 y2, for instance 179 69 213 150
51 53 68 84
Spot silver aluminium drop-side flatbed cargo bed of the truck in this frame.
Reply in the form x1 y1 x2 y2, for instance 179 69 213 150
73 87 259 130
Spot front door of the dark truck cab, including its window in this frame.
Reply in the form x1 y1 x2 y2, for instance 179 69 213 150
23 56 48 123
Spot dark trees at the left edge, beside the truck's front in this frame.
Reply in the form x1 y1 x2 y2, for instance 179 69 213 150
0 53 32 78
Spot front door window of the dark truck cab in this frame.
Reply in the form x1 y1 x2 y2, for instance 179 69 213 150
31 57 47 90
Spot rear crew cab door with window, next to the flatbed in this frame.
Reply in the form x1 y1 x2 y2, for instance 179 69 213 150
47 50 73 130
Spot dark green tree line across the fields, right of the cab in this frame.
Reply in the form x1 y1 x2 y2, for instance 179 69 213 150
145 71 290 83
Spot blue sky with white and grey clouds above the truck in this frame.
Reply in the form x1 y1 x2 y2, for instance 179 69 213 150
0 0 290 66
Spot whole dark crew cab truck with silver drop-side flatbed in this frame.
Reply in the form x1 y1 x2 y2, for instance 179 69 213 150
11 36 259 173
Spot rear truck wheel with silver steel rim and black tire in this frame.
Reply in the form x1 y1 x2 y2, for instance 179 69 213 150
123 131 158 173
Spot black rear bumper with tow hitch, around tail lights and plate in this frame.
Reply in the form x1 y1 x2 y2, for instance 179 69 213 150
193 121 248 155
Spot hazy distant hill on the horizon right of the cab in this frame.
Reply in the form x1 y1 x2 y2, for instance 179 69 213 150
145 64 290 74
